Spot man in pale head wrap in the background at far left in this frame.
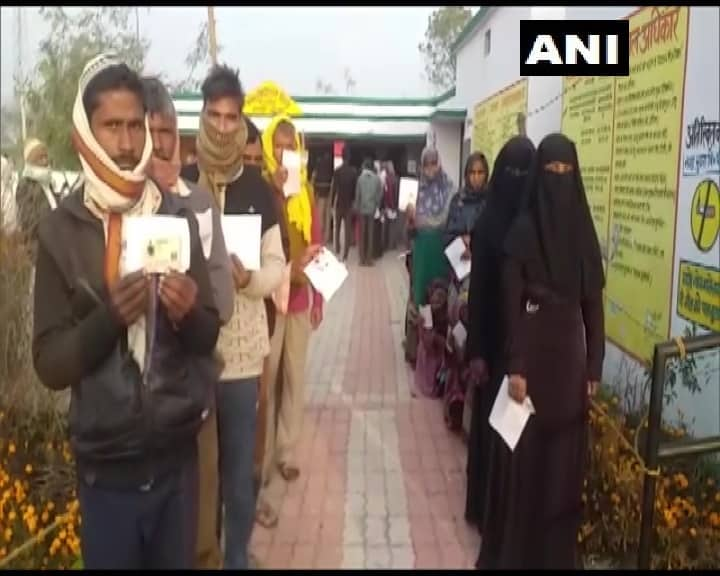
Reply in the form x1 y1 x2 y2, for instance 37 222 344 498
15 138 60 248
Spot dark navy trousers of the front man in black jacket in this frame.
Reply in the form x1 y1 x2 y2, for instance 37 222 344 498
78 454 197 570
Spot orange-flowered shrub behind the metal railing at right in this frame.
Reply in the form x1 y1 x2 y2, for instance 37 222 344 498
578 390 720 569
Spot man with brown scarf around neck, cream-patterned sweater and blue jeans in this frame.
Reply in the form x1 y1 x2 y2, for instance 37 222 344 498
183 66 285 569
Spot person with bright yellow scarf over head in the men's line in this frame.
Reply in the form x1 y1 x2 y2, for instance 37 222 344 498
259 115 323 522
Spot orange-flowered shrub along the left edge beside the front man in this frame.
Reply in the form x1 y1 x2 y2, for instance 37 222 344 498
0 220 80 569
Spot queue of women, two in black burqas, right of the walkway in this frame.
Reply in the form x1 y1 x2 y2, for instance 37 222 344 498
405 129 605 569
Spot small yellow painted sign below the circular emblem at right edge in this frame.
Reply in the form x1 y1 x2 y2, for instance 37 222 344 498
677 260 720 332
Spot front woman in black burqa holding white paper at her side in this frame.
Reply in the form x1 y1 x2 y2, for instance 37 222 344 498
478 134 605 569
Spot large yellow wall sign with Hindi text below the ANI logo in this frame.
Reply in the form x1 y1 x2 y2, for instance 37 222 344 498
562 6 689 360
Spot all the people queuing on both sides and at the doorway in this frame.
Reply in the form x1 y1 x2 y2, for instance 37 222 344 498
26 46 604 569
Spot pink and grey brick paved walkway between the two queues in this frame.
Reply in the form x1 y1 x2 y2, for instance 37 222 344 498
252 254 480 569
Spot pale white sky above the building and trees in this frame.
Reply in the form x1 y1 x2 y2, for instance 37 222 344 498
0 6 442 103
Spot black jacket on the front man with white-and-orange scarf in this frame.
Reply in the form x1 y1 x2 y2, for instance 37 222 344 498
33 189 220 487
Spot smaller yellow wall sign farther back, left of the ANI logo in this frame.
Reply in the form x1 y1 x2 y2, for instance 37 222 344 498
472 79 527 170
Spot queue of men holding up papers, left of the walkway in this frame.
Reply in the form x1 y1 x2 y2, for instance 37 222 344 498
26 54 323 569
